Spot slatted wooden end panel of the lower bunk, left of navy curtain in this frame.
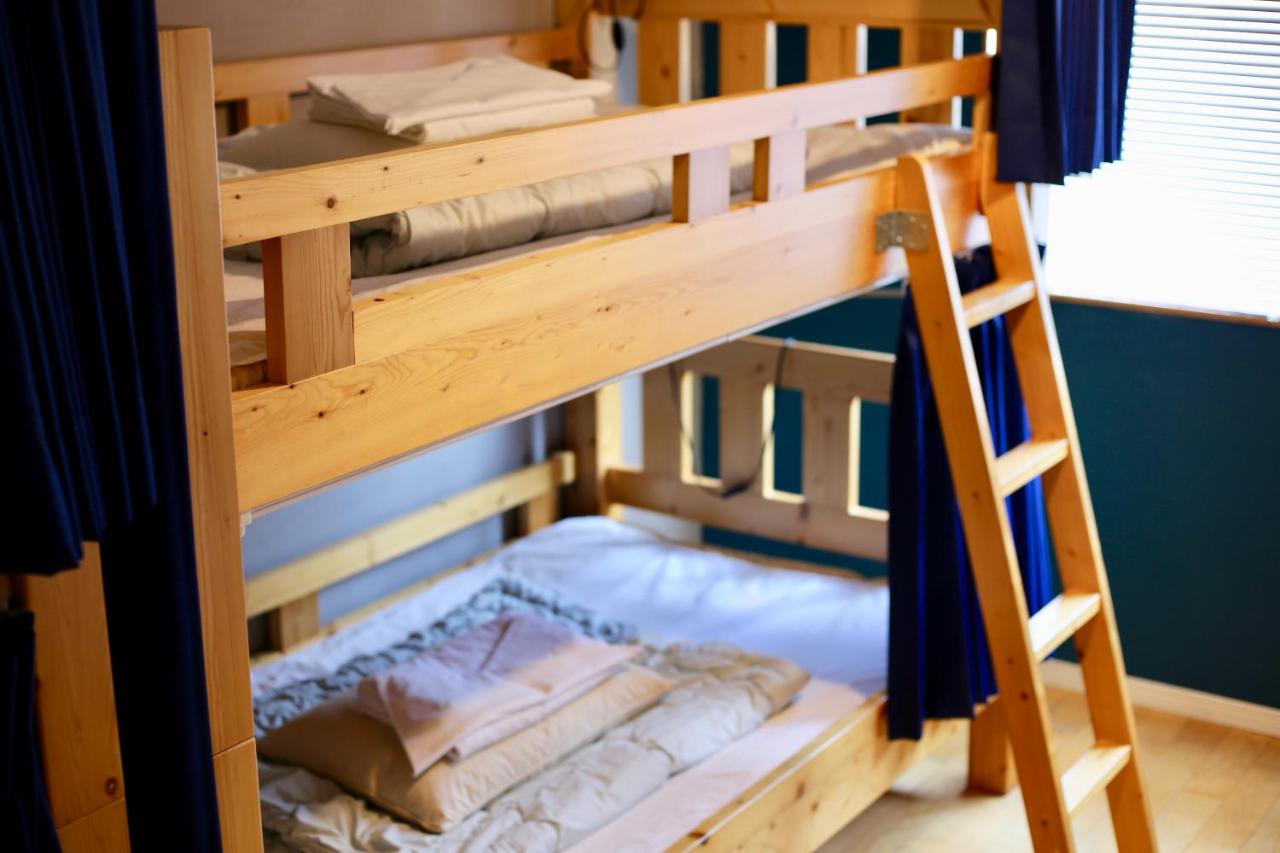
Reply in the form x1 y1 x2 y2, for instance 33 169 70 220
605 338 893 560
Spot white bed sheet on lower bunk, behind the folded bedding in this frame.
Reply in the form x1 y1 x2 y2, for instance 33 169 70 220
253 516 888 697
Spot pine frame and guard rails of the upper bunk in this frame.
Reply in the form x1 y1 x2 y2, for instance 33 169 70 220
161 1 992 511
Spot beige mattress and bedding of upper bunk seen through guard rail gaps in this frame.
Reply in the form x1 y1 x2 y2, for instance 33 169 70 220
225 124 968 369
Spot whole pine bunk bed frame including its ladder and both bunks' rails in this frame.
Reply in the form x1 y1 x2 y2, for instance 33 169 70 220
24 0 1155 850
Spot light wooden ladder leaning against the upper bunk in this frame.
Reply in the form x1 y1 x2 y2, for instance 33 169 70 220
897 134 1156 852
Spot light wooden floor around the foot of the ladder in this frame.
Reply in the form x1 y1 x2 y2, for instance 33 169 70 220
822 690 1280 853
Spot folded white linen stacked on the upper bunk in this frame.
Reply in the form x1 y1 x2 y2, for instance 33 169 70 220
307 56 612 142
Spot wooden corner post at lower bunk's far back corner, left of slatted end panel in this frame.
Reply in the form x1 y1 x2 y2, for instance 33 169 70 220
564 383 622 517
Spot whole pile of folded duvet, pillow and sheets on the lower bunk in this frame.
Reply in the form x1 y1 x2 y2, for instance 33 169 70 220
259 573 808 850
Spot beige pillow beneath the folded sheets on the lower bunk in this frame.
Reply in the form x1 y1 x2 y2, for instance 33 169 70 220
259 666 673 833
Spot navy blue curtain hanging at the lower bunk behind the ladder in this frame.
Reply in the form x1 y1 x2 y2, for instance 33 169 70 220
888 247 1052 739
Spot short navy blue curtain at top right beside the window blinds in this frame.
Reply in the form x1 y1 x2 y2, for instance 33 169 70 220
996 0 1134 183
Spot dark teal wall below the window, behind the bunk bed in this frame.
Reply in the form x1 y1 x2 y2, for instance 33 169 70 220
707 296 1280 707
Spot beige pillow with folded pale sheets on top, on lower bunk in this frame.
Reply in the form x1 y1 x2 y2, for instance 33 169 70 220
261 613 673 833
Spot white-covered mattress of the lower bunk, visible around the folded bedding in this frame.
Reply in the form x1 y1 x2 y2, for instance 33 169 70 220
252 517 888 850
